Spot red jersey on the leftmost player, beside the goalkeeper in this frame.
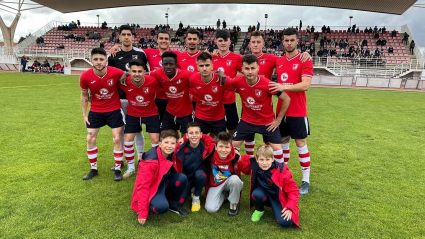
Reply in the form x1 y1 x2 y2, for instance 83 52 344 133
80 66 124 113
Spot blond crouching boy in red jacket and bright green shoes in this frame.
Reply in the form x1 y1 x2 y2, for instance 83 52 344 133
241 145 300 227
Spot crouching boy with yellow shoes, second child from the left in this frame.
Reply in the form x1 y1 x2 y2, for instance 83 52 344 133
173 122 215 212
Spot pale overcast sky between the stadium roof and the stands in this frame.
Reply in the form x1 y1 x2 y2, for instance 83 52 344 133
0 1 425 50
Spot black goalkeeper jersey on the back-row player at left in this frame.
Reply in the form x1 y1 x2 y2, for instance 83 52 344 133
108 47 149 99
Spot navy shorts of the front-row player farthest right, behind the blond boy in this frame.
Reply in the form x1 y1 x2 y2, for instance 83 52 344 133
233 120 281 144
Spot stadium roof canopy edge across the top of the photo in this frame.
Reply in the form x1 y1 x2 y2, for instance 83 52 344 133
33 0 417 15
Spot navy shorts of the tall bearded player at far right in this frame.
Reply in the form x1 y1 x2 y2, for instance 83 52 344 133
279 116 310 139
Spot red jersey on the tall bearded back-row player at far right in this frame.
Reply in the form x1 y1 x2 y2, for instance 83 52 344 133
276 53 313 117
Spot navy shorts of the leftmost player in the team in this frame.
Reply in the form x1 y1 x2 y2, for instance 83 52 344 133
86 109 125 129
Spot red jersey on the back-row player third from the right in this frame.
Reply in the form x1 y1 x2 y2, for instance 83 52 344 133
213 51 242 105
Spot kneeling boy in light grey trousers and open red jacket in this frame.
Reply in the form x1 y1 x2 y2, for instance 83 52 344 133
204 132 250 216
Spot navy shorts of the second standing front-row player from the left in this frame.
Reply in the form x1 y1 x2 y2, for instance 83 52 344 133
124 115 159 134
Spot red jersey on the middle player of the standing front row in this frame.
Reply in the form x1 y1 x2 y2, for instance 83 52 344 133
150 69 193 117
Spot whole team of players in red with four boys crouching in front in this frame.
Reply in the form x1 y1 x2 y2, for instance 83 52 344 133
80 25 313 227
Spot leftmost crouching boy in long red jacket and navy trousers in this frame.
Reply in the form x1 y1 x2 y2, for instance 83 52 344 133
131 130 188 225
